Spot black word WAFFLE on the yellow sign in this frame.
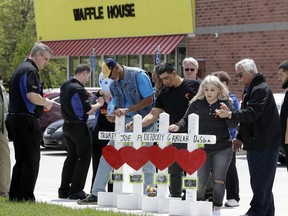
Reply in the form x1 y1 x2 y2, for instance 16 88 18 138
73 6 104 21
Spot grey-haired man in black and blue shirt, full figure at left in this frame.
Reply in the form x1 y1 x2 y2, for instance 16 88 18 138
6 43 53 201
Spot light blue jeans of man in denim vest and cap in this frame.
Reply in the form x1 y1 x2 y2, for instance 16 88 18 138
92 118 156 196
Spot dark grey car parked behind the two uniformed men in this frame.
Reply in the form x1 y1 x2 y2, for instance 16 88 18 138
43 114 95 151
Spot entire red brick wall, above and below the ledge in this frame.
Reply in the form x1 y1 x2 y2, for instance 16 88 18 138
187 0 288 97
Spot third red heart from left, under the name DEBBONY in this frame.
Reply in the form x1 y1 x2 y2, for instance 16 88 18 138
148 145 177 170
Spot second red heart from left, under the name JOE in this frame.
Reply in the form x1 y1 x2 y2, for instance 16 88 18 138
120 146 149 170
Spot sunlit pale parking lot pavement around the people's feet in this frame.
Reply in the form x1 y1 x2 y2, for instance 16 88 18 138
10 142 288 216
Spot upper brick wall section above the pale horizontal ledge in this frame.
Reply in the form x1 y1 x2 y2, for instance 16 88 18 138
195 0 288 27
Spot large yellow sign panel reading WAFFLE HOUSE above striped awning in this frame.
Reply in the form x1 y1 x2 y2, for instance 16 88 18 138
34 0 195 41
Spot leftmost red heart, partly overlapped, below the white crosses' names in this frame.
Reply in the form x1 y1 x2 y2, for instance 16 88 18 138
102 145 124 170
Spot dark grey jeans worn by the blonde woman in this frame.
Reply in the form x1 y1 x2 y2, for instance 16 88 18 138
197 147 232 206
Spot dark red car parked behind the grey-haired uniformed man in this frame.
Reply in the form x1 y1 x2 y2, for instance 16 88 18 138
39 87 101 145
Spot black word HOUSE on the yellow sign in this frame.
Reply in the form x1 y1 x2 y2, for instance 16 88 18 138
107 4 135 19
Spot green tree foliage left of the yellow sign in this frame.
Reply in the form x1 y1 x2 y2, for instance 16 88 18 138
0 0 36 85
